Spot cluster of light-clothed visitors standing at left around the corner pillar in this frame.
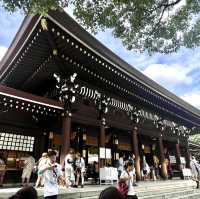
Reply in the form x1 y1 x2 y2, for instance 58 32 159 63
11 149 85 199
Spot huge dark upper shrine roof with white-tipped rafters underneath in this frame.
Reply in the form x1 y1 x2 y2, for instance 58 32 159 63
0 11 200 127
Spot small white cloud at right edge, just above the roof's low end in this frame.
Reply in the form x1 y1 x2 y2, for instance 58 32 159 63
181 91 200 109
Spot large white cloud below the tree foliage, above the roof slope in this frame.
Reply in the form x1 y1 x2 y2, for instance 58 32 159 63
143 64 193 91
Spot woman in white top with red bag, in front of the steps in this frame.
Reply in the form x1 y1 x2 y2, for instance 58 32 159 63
120 161 138 199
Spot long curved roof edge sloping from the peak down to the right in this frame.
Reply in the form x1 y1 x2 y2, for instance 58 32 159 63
48 11 200 117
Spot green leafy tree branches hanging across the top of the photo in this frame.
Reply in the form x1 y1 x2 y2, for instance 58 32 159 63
1 0 200 54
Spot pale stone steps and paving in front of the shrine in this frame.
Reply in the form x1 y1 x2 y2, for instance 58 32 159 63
0 180 196 199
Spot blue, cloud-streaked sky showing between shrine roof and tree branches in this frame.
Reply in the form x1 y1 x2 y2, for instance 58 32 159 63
0 7 200 108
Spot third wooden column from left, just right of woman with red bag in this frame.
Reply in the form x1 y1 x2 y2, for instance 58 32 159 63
132 127 141 180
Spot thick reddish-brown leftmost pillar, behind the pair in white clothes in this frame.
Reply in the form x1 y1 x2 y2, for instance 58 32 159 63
60 116 71 163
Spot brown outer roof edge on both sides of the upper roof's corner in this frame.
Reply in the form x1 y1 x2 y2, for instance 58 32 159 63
0 11 200 120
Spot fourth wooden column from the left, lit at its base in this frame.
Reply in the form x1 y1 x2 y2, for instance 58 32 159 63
158 134 168 179
